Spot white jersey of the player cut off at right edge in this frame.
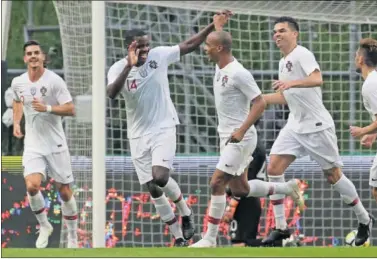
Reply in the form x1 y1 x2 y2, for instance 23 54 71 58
361 70 377 121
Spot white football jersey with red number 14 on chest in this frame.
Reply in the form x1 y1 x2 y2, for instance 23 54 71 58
107 45 180 138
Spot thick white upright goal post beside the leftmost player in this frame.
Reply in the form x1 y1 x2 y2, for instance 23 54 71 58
92 1 106 248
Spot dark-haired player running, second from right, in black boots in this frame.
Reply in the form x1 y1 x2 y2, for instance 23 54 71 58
263 17 373 246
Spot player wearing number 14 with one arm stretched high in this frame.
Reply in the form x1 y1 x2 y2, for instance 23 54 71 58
107 11 231 246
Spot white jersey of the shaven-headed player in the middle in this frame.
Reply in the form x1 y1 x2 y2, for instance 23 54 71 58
213 58 261 139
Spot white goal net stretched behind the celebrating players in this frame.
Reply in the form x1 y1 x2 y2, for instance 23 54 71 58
54 1 377 247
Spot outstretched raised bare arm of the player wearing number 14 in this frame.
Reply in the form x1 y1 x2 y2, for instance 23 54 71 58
179 10 232 56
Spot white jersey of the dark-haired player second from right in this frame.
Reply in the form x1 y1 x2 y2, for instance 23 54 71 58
279 45 334 133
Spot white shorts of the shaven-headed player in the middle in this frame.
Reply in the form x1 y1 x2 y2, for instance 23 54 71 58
216 135 258 176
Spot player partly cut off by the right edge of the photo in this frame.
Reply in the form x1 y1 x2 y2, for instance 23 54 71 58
350 38 377 205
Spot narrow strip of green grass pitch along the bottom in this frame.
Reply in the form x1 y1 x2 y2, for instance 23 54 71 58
1 247 377 258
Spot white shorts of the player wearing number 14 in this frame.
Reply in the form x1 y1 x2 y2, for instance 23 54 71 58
130 127 176 185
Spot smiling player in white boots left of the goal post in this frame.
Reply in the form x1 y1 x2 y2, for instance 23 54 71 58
11 41 77 248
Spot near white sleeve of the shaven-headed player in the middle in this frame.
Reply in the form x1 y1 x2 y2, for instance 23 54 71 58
234 69 262 100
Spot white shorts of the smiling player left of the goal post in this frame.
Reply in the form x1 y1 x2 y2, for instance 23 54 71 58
22 149 73 184
